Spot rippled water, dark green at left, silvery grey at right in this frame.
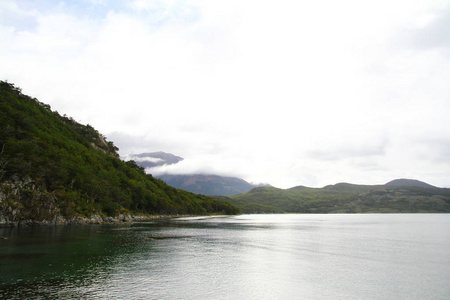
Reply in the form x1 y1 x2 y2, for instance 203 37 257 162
0 214 450 299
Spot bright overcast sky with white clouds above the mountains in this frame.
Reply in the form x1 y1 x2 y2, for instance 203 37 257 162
0 0 450 188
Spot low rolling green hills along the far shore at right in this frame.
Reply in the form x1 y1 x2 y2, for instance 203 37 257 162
220 179 450 213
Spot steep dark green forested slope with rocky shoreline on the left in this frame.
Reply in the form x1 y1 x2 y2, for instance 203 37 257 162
0 81 238 224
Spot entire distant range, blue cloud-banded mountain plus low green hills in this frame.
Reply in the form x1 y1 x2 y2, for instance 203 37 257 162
127 152 450 213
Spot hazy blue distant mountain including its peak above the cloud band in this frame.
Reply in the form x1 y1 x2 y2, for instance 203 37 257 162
128 151 268 196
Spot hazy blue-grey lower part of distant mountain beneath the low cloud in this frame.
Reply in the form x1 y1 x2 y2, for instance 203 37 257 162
157 174 266 196
